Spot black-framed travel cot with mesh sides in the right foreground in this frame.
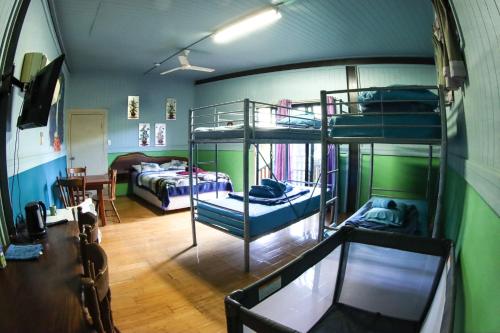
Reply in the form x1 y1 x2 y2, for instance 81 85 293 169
225 227 454 333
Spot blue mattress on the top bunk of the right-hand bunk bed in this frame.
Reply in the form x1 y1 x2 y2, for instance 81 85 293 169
330 112 441 140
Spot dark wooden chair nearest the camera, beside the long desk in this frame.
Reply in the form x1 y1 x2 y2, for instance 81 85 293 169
82 243 119 333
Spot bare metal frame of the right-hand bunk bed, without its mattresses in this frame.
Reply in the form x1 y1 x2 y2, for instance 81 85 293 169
319 86 448 238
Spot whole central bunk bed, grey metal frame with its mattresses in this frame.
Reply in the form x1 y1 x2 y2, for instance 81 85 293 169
189 99 337 272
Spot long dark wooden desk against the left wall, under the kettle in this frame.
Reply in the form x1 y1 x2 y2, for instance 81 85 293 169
0 222 91 333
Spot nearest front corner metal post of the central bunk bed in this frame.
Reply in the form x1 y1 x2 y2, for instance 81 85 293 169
243 98 250 272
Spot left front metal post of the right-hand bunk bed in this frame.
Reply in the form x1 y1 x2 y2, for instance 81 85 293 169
318 90 328 242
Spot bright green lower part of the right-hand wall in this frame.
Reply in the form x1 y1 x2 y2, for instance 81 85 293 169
444 168 500 333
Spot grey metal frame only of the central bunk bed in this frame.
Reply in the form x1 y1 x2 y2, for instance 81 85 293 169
188 98 338 272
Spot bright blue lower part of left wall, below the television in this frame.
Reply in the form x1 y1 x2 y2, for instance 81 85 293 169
9 156 66 218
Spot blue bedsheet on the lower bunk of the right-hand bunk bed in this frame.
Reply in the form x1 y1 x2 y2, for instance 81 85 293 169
343 197 429 236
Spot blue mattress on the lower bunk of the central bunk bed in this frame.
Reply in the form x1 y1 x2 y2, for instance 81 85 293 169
197 189 321 238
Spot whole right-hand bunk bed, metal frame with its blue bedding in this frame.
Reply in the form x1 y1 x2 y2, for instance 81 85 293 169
320 86 447 237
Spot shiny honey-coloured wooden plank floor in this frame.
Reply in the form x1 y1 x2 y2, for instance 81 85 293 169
101 197 317 332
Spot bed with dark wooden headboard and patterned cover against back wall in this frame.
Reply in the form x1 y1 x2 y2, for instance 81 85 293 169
110 153 232 212
